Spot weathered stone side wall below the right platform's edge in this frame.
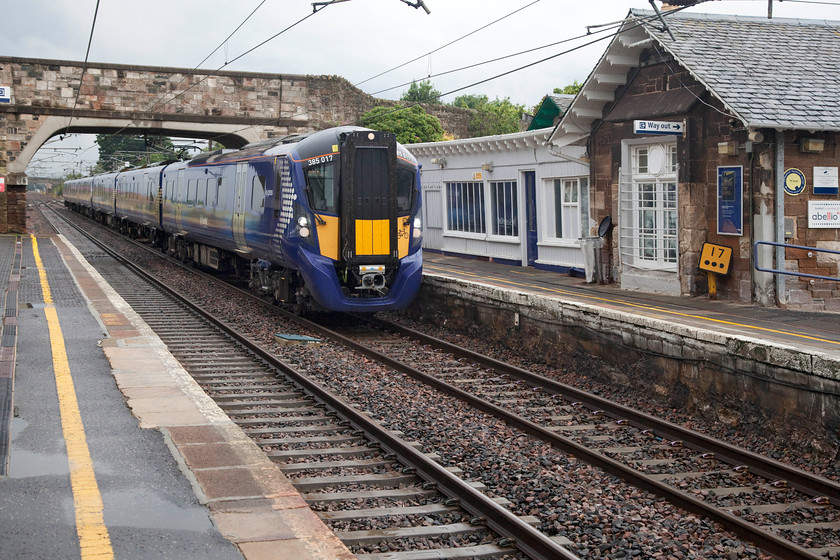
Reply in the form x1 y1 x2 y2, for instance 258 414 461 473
406 277 840 447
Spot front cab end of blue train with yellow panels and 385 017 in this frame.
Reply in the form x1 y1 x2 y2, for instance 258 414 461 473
301 130 422 312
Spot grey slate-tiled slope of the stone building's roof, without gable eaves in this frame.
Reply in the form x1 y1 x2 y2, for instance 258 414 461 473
629 10 840 130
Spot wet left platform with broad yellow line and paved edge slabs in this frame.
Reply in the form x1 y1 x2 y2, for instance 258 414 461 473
0 231 352 560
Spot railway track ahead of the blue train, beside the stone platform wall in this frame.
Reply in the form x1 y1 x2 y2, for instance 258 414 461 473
42 199 840 558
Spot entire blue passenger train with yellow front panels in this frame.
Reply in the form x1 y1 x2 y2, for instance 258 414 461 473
63 126 423 313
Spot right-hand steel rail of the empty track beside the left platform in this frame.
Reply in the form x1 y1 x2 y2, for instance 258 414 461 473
44 205 580 560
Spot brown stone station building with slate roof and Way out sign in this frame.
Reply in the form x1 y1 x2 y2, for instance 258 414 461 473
546 10 840 311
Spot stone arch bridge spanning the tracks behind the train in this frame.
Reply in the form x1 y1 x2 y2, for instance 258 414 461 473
0 57 469 233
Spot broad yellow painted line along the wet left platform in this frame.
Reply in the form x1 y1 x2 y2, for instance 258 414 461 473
31 235 114 560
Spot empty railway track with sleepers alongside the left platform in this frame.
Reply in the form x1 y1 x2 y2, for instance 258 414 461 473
42 199 577 560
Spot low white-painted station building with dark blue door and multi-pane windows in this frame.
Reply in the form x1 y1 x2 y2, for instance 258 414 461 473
406 127 592 274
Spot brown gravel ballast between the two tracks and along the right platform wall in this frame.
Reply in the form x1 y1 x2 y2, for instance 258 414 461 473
39 201 837 560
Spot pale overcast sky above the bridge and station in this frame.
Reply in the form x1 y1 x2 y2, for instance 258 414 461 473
6 0 840 176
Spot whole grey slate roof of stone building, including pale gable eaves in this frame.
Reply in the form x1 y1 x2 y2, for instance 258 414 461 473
549 9 840 145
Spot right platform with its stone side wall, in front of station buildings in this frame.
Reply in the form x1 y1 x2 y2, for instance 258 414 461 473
424 252 840 445
